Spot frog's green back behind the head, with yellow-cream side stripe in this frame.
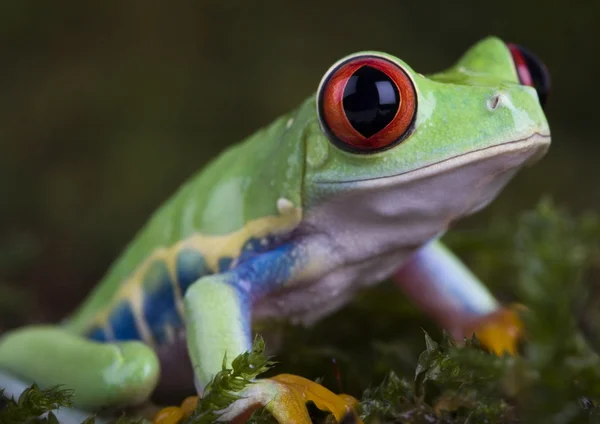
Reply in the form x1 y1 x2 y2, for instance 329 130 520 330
65 98 315 336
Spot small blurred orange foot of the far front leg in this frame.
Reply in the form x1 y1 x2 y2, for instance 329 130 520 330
469 305 525 356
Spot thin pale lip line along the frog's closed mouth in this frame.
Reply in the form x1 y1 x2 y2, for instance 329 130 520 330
315 132 550 185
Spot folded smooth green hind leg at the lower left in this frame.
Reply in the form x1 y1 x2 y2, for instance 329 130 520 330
0 326 159 411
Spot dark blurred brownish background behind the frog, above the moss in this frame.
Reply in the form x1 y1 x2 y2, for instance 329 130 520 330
0 0 600 331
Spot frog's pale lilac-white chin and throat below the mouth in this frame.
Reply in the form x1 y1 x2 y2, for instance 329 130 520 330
305 133 550 261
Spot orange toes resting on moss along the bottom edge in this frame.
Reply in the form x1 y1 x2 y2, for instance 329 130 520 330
154 374 362 424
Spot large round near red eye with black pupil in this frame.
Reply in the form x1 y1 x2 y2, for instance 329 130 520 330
318 56 417 153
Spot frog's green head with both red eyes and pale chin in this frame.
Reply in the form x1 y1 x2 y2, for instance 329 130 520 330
303 38 550 248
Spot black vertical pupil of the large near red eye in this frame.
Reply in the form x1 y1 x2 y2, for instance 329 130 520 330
343 66 400 138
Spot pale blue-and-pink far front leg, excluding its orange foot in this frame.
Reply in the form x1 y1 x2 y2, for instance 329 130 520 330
394 241 500 338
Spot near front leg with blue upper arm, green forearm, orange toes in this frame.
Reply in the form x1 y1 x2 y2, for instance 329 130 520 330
155 244 358 424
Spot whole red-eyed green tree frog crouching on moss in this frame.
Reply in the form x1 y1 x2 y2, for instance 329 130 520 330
0 37 550 424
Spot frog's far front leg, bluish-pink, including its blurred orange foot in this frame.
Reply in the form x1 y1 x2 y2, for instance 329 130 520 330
394 241 523 355
